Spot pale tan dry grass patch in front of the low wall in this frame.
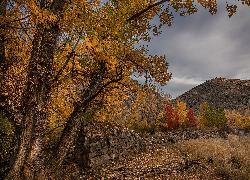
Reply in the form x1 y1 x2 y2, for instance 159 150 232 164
171 135 250 179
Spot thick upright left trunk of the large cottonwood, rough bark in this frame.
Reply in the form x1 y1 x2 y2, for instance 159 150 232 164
5 0 65 180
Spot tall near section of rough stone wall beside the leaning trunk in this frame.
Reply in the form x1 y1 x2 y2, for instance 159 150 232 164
72 121 146 168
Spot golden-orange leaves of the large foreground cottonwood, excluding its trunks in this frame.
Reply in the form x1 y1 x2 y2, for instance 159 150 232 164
3 0 248 141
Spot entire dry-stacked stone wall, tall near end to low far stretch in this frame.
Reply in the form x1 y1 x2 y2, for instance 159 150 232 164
69 121 230 168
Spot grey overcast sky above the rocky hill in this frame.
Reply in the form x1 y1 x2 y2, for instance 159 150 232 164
131 0 250 98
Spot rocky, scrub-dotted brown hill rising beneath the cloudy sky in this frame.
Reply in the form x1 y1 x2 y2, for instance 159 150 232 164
171 78 250 115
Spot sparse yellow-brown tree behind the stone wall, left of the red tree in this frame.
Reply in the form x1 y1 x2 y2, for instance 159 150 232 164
125 84 168 133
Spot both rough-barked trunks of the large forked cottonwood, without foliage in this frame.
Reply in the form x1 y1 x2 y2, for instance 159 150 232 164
2 0 107 180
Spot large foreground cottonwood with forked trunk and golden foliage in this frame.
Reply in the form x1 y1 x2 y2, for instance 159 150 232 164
0 0 247 180
